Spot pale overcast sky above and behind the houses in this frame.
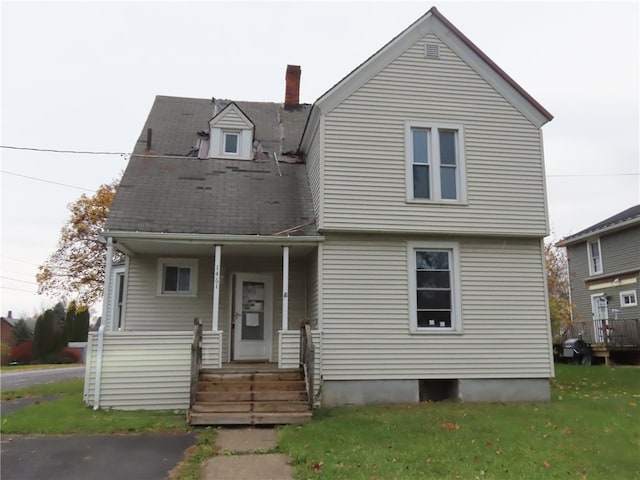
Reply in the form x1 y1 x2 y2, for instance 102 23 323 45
0 1 640 316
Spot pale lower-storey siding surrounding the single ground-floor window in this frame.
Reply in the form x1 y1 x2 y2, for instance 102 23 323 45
322 235 553 380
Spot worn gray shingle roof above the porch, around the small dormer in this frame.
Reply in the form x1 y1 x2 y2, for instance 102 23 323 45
105 96 317 235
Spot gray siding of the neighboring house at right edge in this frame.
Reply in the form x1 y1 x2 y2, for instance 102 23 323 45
567 227 640 321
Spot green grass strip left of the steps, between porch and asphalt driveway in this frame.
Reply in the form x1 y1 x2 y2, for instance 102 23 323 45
0 379 189 435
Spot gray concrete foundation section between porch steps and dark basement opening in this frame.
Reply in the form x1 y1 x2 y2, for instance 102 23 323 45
321 380 419 407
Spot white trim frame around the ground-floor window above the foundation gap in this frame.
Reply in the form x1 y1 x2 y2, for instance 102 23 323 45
407 242 463 335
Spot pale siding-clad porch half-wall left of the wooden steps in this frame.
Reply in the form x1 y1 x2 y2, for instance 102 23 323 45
84 331 193 410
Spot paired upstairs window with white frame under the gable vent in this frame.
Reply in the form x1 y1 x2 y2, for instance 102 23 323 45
405 122 466 202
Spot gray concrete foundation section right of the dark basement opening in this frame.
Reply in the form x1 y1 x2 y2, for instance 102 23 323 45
458 378 551 402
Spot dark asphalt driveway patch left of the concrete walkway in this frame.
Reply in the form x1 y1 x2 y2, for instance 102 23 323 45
0 433 197 480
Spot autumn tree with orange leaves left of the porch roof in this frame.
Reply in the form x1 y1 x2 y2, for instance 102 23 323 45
36 181 119 305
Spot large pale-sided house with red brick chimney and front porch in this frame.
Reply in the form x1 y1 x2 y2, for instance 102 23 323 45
85 8 554 416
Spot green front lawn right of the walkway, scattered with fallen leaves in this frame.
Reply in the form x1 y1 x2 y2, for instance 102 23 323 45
279 365 640 480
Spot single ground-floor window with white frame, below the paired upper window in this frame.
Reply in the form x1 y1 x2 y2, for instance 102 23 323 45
408 242 462 332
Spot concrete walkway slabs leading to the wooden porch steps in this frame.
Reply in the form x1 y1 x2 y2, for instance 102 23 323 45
200 428 293 480
